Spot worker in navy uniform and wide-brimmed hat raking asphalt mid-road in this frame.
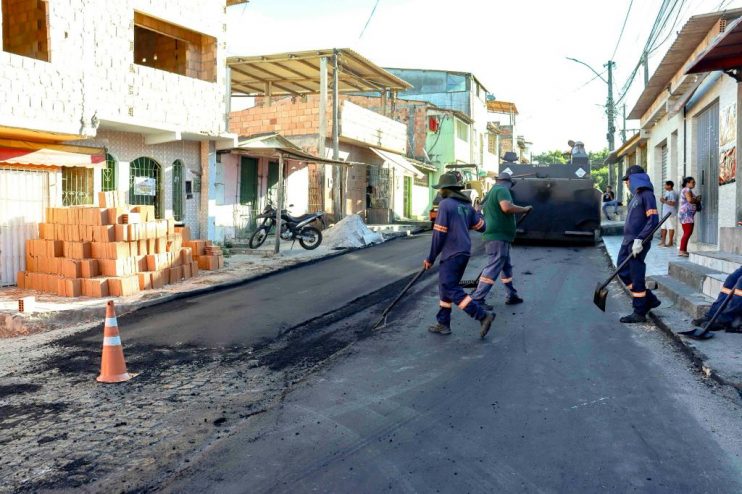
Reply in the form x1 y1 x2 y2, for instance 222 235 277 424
423 173 495 338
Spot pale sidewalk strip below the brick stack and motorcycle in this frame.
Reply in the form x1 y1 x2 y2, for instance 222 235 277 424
0 237 354 339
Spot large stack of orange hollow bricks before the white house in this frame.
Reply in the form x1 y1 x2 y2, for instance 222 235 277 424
17 195 224 297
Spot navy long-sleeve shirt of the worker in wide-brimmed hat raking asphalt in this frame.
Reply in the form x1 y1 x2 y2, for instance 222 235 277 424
428 197 486 264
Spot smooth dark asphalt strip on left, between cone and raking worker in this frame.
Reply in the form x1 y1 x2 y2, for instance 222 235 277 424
87 235 430 347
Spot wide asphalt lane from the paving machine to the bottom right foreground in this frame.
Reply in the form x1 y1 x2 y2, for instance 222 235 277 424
163 243 742 493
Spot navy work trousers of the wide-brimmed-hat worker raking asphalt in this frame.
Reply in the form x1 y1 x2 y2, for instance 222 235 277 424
436 254 485 327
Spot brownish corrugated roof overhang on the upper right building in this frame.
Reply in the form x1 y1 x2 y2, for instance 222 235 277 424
628 9 742 120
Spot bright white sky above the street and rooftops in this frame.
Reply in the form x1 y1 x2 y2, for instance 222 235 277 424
228 0 742 151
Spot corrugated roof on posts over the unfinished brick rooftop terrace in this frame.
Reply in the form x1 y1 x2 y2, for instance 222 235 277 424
227 48 411 96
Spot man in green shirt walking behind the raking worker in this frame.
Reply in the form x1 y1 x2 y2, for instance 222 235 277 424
471 172 533 311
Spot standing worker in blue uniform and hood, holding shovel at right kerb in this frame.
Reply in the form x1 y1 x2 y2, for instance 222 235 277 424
618 165 661 323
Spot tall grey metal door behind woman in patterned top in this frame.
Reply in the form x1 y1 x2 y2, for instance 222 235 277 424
695 102 719 244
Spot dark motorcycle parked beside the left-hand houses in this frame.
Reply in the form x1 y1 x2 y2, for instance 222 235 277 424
250 201 325 250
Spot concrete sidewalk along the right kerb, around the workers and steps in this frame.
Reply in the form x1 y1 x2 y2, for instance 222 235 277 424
603 235 742 392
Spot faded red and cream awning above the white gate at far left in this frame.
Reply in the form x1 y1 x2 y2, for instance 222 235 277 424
0 144 106 168
